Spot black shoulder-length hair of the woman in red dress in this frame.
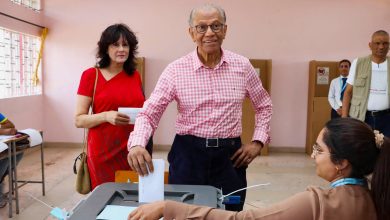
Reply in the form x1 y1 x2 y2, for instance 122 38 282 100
96 24 138 75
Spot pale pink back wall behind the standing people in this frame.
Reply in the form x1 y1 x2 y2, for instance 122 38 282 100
0 0 390 148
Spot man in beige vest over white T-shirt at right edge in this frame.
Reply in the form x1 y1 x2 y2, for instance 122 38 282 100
342 30 390 137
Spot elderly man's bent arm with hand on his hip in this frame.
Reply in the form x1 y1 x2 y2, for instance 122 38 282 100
231 61 272 167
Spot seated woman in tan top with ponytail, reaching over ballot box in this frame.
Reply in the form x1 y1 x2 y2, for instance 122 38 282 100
128 118 390 220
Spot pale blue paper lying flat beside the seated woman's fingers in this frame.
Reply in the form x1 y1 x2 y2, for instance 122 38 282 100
96 205 137 220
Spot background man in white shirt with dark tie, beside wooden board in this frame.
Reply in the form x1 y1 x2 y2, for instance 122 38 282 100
328 60 351 119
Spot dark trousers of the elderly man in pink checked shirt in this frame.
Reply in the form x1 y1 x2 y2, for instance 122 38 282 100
168 135 247 211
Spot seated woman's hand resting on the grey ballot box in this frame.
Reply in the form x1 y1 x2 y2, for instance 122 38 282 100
127 201 166 220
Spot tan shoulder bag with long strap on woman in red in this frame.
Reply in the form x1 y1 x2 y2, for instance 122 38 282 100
73 68 98 194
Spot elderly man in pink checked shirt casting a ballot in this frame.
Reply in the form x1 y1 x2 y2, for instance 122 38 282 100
128 4 272 211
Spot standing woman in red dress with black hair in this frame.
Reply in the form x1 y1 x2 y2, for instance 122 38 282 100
75 24 149 189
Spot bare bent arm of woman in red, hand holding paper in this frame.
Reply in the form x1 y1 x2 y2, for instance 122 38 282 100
75 95 130 128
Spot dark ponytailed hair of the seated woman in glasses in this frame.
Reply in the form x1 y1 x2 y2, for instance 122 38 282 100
323 118 390 220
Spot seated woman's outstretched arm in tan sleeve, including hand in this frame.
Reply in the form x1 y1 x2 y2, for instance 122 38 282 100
128 191 319 220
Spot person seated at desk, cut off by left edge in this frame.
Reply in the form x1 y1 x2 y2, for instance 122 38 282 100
0 113 23 208
